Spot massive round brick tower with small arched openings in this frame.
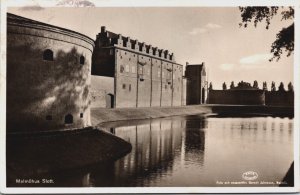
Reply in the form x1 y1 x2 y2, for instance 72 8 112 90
6 13 94 132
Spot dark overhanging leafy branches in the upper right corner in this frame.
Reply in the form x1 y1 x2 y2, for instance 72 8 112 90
239 6 294 61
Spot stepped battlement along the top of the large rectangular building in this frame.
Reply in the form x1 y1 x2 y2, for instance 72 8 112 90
95 26 175 62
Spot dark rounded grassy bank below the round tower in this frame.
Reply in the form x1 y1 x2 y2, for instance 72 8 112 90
7 128 131 186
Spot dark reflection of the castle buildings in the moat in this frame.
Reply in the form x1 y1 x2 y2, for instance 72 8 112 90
107 118 207 186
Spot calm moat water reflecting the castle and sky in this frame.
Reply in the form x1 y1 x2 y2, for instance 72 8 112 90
39 115 293 187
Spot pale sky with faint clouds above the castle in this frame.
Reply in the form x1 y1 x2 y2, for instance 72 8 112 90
7 4 294 89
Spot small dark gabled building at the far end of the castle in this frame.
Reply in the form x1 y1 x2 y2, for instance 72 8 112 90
185 63 207 105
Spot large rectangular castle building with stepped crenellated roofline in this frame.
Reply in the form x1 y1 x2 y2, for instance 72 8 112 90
92 26 183 108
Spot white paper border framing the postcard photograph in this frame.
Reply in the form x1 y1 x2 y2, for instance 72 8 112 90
0 0 300 194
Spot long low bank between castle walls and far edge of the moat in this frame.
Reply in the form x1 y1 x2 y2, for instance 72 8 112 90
91 104 294 126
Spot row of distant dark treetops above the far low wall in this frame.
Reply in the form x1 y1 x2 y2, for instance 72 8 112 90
208 80 294 92
